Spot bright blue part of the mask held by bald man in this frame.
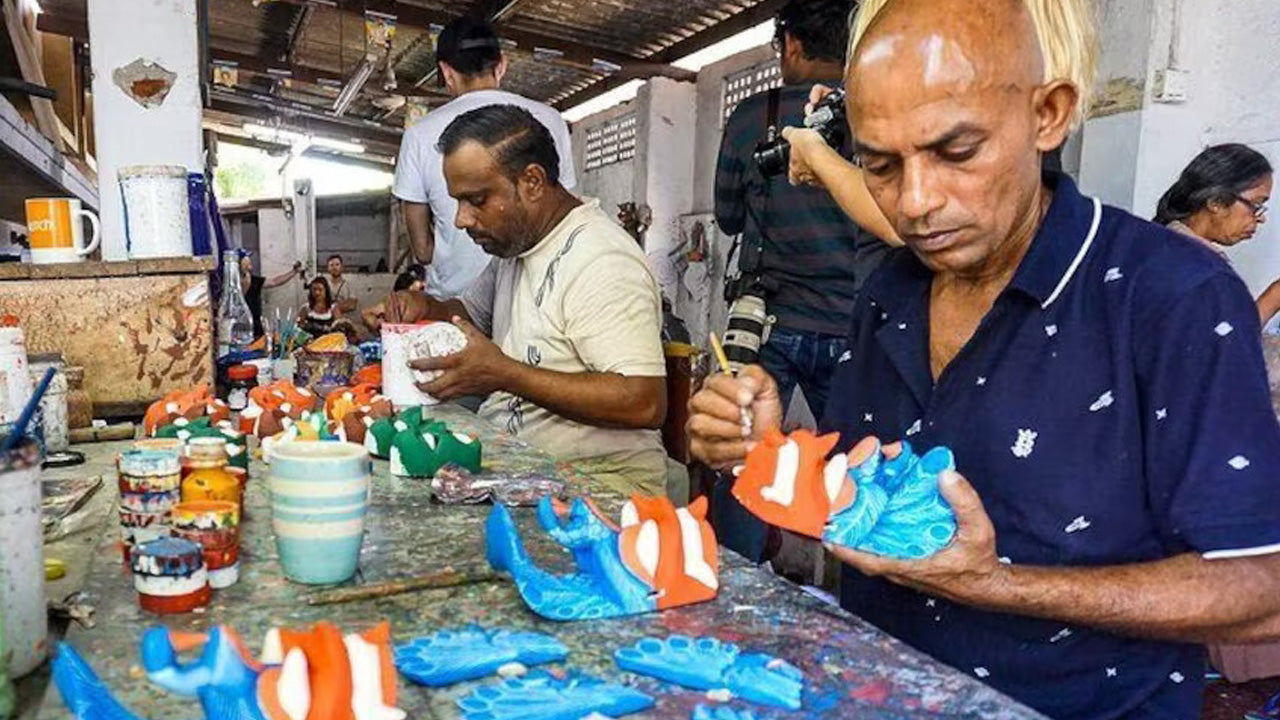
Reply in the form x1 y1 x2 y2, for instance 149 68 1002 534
823 441 956 560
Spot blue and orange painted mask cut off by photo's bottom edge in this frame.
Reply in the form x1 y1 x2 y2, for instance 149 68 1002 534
52 623 404 720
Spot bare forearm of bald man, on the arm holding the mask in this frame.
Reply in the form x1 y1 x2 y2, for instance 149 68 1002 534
952 545 1280 643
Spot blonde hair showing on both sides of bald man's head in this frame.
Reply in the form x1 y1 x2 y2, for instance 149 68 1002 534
849 0 1098 129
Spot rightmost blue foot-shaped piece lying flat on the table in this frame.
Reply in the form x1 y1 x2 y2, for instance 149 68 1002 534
613 635 804 710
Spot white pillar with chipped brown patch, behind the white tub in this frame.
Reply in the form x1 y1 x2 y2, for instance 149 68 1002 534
87 0 204 260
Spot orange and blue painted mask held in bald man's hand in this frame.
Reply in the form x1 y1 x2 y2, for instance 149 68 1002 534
732 430 956 560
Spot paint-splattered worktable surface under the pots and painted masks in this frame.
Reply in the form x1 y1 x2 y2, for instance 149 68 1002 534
37 407 1041 720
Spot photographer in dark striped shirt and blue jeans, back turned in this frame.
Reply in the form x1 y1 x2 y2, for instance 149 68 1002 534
716 0 887 561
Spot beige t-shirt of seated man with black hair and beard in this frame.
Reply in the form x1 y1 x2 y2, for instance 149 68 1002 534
461 199 667 495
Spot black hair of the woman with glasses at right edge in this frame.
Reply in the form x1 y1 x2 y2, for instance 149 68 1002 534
1155 142 1271 225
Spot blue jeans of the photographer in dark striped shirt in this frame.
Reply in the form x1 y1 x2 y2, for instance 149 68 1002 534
712 328 849 562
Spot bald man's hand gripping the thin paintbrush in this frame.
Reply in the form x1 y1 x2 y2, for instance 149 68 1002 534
687 365 782 468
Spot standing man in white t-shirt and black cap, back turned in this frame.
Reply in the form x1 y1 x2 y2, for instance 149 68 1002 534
392 18 576 300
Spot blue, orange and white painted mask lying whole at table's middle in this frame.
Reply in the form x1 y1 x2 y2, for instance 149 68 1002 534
485 496 719 620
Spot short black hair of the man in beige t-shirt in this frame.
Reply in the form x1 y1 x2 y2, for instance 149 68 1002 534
435 105 559 184
